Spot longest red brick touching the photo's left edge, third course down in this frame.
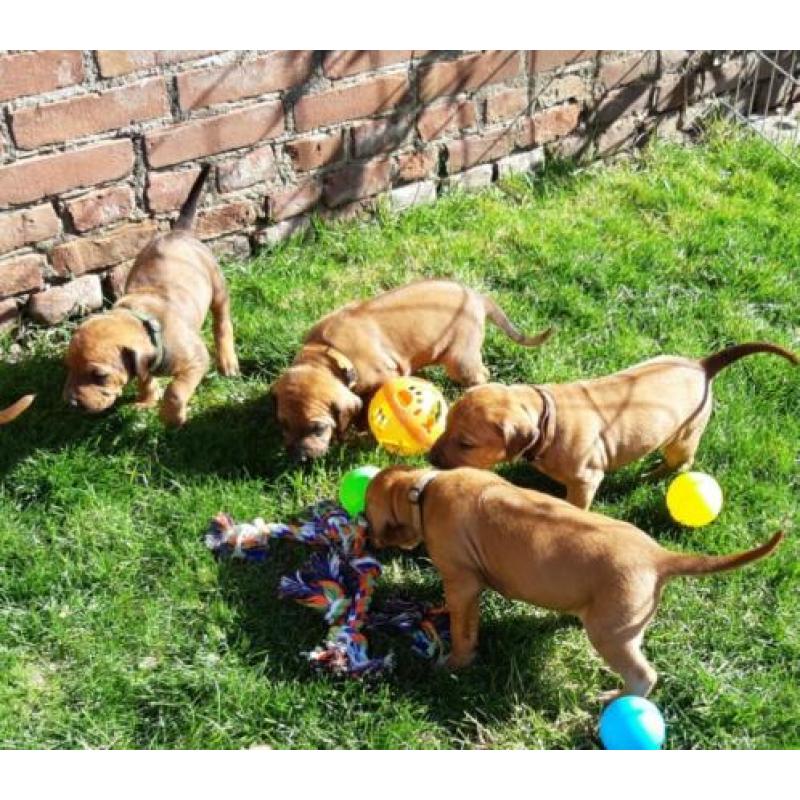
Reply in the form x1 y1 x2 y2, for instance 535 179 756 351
0 139 133 207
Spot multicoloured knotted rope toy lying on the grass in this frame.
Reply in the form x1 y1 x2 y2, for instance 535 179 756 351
205 500 449 676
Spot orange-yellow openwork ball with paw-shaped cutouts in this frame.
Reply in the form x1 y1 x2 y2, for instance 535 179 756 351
368 378 447 456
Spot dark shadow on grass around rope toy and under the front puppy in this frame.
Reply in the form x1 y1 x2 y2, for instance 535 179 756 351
212 545 589 746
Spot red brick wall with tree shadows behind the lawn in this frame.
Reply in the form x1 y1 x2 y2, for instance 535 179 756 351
0 50 780 328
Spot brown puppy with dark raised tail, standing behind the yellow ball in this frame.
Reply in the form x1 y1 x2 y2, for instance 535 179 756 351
430 342 798 508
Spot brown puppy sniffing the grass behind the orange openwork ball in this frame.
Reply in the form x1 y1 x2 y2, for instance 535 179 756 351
272 280 551 461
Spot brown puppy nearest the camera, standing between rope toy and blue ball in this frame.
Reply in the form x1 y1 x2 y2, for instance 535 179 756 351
366 467 783 700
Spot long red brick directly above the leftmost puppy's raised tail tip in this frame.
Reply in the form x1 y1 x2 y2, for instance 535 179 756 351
145 101 283 167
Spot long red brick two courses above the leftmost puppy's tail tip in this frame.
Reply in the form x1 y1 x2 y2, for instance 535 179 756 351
178 50 314 110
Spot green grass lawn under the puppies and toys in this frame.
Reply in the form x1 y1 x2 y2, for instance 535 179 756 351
0 122 800 748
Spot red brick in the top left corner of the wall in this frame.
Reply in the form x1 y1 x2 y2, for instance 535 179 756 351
0 50 83 101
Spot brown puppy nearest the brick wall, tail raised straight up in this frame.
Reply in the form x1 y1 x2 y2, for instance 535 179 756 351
64 165 239 425
